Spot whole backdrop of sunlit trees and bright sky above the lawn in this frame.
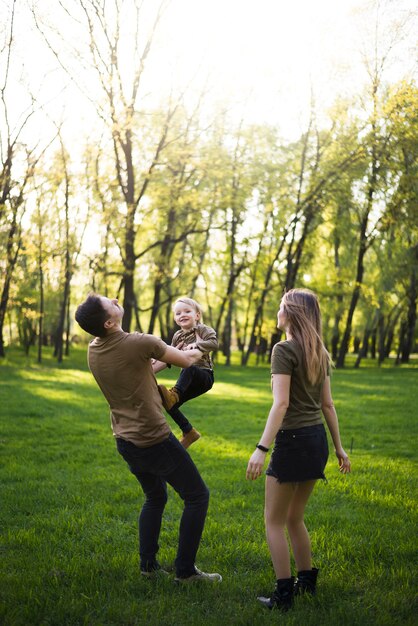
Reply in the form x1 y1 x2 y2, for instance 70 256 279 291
0 0 418 367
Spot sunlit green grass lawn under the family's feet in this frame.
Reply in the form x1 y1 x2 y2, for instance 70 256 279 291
0 348 418 626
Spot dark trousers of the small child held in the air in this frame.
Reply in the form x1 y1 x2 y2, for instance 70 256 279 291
168 365 213 433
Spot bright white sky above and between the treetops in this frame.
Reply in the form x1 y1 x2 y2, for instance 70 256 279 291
0 0 416 143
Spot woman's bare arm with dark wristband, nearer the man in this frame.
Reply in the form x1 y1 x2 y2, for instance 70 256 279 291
247 374 291 480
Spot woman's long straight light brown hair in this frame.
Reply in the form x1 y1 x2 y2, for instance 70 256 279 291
282 289 331 385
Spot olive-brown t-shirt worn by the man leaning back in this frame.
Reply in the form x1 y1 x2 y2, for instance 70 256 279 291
88 330 171 448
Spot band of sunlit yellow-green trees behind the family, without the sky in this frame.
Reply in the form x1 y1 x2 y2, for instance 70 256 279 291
0 36 418 362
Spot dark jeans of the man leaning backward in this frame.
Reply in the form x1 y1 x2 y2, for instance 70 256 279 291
116 433 209 578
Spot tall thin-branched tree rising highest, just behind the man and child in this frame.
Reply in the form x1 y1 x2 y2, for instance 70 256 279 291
33 0 178 331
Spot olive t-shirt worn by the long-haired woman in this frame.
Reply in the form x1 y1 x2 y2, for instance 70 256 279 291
271 340 323 430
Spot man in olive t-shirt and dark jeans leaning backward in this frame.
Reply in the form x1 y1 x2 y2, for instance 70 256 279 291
75 294 222 582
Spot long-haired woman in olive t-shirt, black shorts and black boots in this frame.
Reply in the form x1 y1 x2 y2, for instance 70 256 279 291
247 289 351 611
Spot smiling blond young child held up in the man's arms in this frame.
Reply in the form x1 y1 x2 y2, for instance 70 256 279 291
153 298 218 448
